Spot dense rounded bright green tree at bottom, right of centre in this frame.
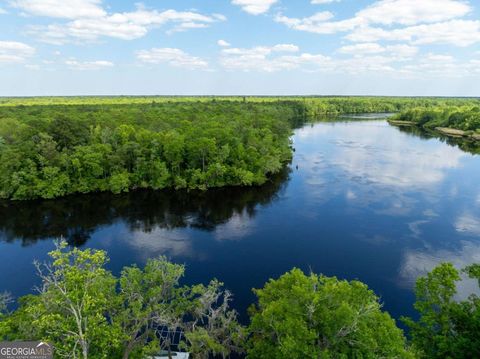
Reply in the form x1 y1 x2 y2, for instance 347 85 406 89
247 269 411 359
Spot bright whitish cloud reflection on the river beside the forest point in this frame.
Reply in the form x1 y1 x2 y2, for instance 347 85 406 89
296 121 466 194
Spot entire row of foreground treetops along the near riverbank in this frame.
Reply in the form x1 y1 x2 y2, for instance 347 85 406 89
0 242 480 359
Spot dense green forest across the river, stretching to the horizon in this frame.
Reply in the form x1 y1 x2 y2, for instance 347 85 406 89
0 97 480 200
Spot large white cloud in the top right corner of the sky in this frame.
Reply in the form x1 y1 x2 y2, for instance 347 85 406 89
275 0 480 46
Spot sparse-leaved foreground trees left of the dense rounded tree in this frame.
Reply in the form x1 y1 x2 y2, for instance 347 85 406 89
0 242 244 359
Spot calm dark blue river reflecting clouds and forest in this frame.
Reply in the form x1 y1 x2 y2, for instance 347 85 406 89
0 118 480 320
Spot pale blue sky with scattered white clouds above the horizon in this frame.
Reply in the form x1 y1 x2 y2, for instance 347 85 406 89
0 0 480 96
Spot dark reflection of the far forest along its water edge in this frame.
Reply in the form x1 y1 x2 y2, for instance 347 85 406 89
0 166 290 246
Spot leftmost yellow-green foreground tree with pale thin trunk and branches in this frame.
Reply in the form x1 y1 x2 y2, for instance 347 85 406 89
0 242 120 358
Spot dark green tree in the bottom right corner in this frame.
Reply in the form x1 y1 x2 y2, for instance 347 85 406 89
403 263 480 358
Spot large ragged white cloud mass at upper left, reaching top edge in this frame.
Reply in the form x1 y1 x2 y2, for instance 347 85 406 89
14 0 226 45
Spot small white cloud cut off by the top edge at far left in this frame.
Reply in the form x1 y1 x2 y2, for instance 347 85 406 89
10 0 107 19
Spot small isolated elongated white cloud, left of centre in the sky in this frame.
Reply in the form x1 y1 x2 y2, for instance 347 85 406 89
136 48 208 70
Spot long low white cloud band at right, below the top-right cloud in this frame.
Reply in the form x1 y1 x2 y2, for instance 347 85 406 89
219 43 480 78
